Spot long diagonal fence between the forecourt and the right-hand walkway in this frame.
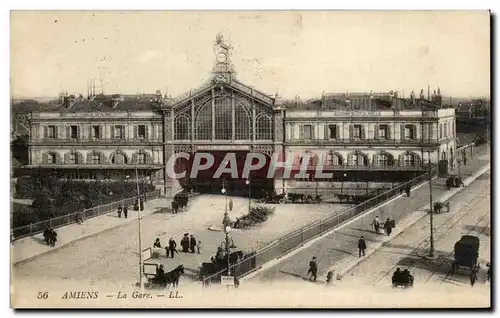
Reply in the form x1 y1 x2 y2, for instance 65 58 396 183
202 167 437 286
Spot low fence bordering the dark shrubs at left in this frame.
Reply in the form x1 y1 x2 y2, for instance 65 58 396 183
12 189 161 239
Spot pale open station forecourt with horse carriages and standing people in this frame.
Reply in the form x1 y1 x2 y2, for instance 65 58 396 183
13 195 349 287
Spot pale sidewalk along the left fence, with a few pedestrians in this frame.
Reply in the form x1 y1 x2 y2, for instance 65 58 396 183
11 198 171 264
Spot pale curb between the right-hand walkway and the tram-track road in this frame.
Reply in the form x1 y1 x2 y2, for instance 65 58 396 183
334 164 490 280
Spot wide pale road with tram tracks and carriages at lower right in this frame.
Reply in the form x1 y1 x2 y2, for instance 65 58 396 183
339 173 491 290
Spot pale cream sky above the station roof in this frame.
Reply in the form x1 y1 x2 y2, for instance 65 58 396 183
11 11 490 98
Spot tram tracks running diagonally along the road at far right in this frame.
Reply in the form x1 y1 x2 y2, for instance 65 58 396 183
373 192 490 285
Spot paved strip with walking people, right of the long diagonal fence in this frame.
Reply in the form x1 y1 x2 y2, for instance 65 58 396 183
249 149 489 283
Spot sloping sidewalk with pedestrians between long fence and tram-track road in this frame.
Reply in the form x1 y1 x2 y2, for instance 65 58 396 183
247 147 490 282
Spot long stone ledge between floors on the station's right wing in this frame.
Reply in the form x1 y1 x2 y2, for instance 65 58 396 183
285 138 439 147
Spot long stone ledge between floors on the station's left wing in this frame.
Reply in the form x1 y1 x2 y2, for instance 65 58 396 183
29 138 163 146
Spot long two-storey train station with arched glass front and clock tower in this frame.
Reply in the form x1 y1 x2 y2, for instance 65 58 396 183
27 37 456 198
